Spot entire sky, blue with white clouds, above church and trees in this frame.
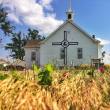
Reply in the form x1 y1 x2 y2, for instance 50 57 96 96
0 0 110 57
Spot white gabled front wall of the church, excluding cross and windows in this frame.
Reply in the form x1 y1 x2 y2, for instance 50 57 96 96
40 23 98 65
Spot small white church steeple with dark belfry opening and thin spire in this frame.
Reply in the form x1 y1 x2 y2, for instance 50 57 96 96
66 0 73 21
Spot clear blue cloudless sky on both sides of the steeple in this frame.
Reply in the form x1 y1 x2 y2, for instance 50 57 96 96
53 0 110 40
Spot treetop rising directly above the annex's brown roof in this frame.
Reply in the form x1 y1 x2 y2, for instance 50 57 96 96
27 29 45 40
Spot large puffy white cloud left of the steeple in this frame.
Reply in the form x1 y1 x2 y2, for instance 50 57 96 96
0 0 63 34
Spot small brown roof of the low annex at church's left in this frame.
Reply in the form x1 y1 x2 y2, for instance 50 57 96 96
24 40 41 48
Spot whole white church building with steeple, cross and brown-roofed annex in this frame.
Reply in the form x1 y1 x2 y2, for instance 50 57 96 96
25 1 102 67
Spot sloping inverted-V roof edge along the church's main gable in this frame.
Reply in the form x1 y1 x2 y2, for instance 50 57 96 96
42 20 100 44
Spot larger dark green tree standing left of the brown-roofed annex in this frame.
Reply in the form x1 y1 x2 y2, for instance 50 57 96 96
5 32 26 60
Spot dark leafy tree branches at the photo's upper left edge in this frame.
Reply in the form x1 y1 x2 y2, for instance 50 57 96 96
0 5 14 35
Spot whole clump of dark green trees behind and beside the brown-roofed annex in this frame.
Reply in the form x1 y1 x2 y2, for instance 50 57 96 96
5 29 44 60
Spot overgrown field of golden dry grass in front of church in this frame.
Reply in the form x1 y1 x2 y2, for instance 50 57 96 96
0 66 110 110
